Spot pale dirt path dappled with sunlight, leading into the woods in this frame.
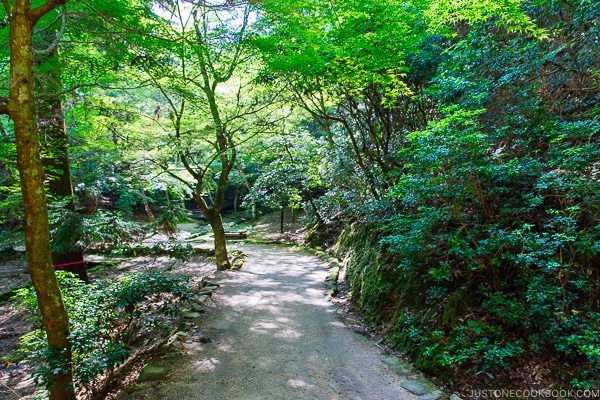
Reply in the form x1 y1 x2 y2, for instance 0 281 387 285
122 244 419 400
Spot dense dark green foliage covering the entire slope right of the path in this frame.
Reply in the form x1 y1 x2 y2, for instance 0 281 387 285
310 1 600 388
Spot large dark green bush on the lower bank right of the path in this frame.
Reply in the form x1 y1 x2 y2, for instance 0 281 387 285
338 94 600 387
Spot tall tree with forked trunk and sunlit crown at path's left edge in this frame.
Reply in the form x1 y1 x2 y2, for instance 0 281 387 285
134 2 282 270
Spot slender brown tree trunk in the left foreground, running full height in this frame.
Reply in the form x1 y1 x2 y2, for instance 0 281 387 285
7 0 75 400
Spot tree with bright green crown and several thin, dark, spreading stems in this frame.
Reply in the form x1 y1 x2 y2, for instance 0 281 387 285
257 0 431 200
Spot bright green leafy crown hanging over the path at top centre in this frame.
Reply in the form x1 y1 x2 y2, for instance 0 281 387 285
258 0 418 98
